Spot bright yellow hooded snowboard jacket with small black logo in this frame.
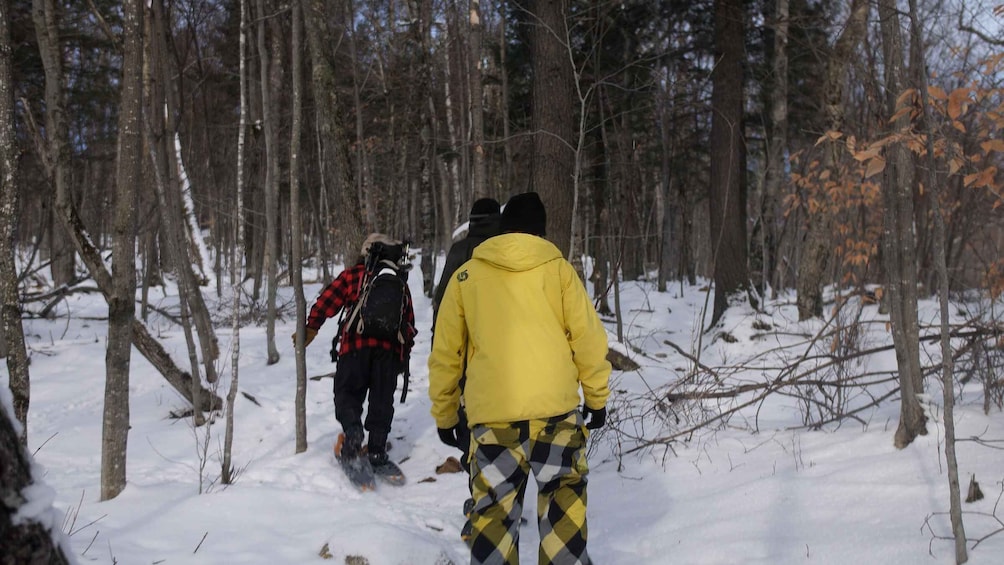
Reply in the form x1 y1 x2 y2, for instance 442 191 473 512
429 233 610 428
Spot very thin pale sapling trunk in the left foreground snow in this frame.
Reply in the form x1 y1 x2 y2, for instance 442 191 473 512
220 0 249 485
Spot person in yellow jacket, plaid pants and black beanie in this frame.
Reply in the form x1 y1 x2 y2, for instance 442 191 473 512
429 193 610 565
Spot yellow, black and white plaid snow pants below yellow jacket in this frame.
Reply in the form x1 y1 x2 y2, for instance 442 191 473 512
470 410 589 565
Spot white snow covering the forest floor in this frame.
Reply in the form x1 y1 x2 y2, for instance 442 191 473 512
0 252 1004 565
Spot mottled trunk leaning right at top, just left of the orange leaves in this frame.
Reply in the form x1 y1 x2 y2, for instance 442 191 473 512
795 0 869 320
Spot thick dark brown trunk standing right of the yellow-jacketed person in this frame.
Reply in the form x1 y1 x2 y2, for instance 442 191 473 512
709 0 749 326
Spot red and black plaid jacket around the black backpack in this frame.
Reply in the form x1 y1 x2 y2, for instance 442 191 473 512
307 263 418 358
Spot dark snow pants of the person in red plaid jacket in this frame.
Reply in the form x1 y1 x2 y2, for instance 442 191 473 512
334 347 403 454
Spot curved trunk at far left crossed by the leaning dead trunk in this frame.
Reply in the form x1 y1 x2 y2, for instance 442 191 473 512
31 0 75 286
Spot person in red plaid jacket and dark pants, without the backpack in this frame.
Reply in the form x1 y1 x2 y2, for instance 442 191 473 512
294 234 418 467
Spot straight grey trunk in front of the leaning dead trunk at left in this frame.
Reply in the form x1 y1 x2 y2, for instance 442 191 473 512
101 0 144 501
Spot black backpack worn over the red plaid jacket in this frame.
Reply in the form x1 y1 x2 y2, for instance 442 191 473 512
345 242 411 343
